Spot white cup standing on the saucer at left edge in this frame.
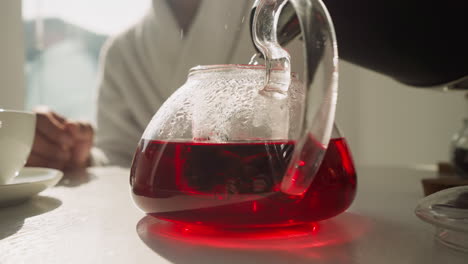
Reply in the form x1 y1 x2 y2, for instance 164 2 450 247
0 109 36 184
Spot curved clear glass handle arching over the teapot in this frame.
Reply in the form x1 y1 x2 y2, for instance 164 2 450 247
252 0 338 195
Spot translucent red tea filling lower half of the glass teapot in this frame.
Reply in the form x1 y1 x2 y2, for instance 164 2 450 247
130 138 356 227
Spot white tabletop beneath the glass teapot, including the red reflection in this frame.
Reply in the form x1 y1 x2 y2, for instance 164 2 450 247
0 167 468 264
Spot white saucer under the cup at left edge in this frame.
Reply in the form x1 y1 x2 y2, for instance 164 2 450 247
0 167 63 206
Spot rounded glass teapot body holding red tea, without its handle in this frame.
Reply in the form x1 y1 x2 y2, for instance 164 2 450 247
130 65 356 227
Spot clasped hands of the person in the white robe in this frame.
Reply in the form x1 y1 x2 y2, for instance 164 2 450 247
26 109 94 170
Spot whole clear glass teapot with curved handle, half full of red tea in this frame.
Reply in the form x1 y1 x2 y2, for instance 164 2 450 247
130 0 356 227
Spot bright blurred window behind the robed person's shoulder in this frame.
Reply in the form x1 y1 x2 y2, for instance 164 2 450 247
22 0 151 122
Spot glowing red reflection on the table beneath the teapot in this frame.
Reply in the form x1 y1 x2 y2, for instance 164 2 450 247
137 213 371 250
